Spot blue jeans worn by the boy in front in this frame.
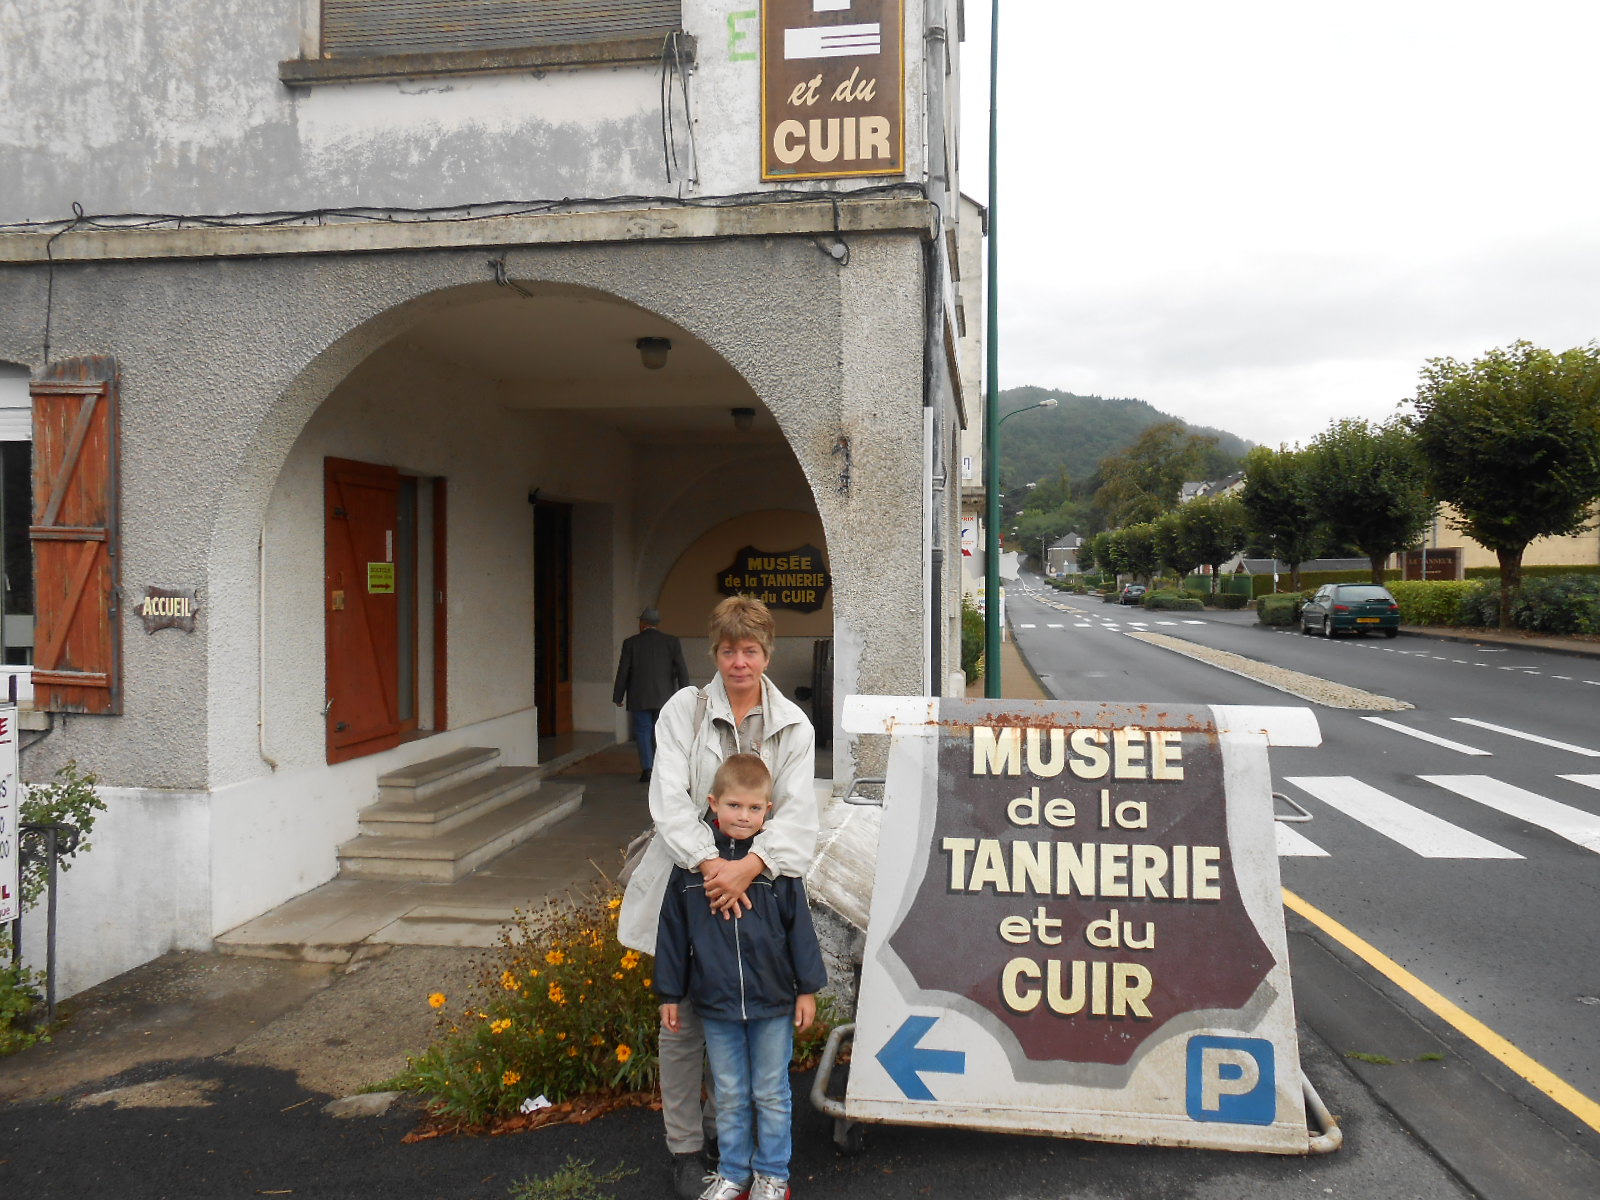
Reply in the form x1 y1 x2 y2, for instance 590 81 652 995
701 1013 795 1184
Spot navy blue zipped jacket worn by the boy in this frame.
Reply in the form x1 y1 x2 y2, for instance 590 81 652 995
654 816 827 1021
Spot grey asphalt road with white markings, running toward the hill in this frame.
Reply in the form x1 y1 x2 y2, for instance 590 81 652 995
1008 578 1600 1177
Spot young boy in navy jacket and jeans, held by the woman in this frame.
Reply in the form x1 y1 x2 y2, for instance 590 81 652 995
654 754 827 1200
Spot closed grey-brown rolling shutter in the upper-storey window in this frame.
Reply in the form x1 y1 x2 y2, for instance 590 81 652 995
322 0 683 58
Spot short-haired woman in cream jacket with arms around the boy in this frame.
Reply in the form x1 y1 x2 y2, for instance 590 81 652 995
618 595 819 1200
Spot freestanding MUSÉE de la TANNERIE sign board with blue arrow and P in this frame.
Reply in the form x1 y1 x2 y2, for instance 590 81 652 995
842 696 1320 1154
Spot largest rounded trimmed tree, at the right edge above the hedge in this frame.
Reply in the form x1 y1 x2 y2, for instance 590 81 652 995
1411 341 1600 629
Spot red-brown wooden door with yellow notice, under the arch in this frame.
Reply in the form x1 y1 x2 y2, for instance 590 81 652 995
323 458 406 763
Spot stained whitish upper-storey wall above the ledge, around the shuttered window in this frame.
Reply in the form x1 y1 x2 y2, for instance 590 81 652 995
0 0 934 222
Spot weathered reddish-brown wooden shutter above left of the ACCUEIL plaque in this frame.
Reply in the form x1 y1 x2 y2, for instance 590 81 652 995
29 355 122 714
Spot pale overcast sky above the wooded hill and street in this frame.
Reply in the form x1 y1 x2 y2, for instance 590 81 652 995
962 0 1600 445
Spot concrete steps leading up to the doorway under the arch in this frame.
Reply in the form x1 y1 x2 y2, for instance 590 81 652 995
339 747 584 883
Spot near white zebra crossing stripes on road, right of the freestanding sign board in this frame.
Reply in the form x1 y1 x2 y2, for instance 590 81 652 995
1275 717 1600 859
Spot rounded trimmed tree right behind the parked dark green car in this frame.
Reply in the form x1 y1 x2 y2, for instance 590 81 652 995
1306 419 1437 584
